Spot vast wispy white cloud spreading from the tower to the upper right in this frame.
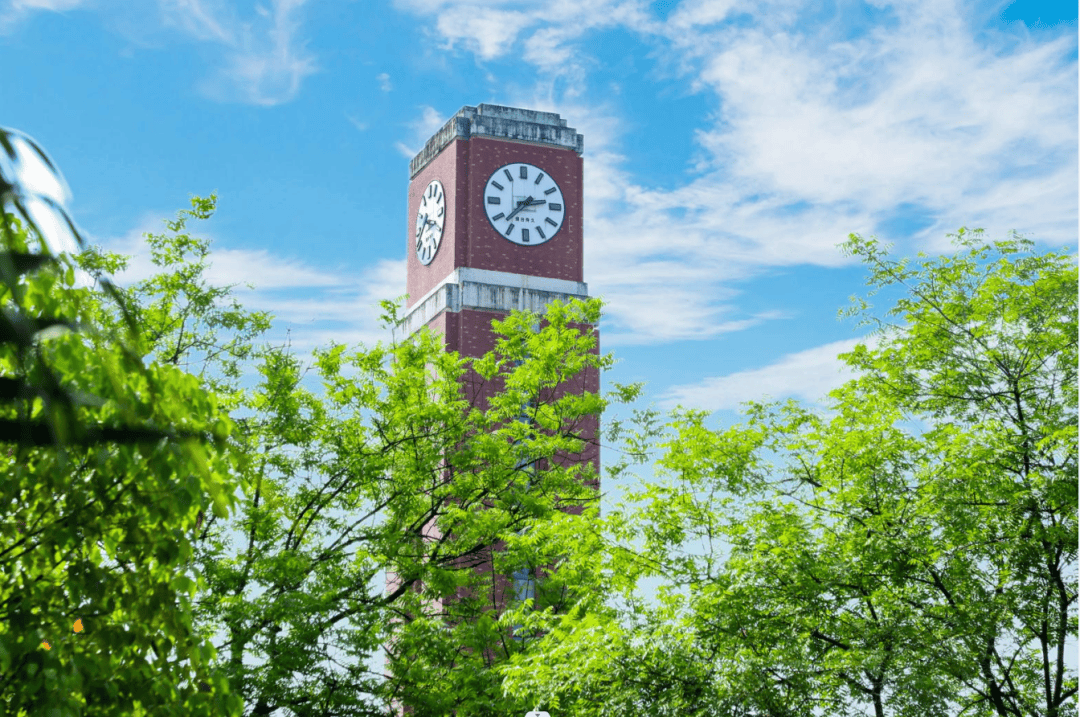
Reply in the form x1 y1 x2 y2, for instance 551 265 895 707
396 0 1078 346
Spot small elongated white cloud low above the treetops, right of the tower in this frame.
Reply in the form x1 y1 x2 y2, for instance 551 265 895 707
658 339 874 411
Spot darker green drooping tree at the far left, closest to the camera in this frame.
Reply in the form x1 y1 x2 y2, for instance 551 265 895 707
0 131 240 716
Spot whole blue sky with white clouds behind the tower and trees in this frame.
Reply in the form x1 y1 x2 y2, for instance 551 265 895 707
0 0 1078 436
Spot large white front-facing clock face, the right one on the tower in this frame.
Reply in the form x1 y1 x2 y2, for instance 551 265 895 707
484 162 566 246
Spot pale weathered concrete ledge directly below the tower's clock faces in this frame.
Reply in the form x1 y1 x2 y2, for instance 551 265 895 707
394 267 589 340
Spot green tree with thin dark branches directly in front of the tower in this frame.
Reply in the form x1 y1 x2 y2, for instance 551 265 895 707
83 197 635 716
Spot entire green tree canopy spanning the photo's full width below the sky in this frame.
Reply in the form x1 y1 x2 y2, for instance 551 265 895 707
0 133 1078 717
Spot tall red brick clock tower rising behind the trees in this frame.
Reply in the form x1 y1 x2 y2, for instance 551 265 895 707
395 105 599 617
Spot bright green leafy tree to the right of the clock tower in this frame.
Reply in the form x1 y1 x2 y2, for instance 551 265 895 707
503 230 1077 717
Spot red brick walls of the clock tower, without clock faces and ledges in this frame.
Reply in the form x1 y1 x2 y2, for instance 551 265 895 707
405 116 600 609
